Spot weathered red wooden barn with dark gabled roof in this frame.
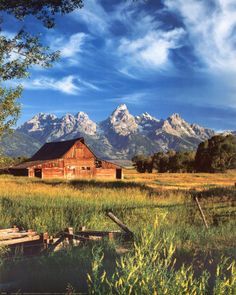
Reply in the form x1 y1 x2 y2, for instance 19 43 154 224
10 138 122 179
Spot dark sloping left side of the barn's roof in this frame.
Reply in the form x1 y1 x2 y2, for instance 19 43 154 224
29 137 84 161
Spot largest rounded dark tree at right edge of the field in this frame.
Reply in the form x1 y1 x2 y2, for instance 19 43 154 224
195 135 236 172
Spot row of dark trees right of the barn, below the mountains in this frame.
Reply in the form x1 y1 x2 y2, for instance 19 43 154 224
132 135 236 173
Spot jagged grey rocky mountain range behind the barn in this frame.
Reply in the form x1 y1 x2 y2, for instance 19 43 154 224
0 104 218 159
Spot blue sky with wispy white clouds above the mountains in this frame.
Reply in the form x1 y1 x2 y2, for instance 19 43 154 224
4 0 236 130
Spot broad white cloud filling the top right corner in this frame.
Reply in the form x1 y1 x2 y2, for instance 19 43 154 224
165 0 236 71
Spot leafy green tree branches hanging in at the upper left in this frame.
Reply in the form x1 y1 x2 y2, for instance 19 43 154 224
0 0 83 136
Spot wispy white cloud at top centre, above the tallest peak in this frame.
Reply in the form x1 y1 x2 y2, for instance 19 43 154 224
71 0 184 77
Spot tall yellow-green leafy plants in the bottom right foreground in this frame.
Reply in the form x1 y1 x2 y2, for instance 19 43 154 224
88 219 236 295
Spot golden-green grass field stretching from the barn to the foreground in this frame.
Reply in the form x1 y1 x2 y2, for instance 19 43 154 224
0 170 236 294
